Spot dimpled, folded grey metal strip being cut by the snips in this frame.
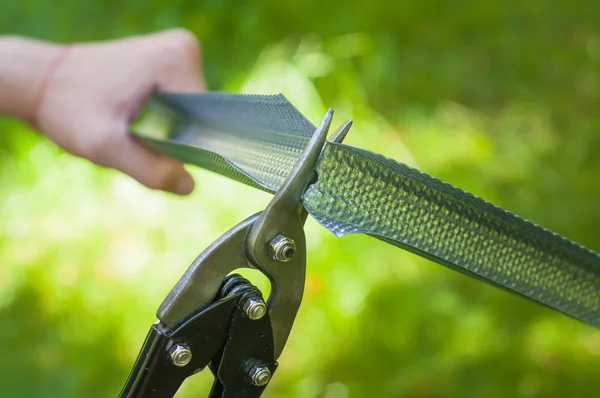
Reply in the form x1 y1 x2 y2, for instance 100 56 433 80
135 93 600 327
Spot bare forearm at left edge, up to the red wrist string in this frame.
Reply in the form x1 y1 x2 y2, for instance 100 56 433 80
0 36 60 119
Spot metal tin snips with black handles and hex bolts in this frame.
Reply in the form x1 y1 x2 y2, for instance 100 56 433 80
119 109 352 398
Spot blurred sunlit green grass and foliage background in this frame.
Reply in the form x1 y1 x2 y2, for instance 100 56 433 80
0 0 600 398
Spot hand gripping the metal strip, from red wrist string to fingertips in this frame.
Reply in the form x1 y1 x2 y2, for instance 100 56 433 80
28 29 204 195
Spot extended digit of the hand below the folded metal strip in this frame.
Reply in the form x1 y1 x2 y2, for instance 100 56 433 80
101 134 194 195
